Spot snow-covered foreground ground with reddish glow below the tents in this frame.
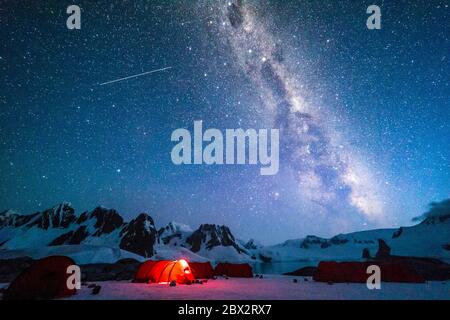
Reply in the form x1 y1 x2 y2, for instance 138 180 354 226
51 276 450 300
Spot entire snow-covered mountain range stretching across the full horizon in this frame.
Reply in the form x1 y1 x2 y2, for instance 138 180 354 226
0 203 450 263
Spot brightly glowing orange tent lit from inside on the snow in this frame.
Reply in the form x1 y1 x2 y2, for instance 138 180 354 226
134 259 194 284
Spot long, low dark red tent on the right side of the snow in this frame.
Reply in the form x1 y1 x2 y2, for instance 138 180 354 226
314 261 425 283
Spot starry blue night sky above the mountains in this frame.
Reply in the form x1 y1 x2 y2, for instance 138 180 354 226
0 0 450 244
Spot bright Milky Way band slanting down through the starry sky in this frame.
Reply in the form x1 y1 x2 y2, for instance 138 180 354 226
209 1 384 222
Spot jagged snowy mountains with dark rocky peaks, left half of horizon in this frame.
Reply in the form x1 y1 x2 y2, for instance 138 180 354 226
0 202 251 263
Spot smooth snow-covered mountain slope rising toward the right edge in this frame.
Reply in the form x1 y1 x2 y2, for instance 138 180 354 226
253 214 450 261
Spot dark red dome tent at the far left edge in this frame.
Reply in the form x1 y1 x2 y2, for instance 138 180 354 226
3 256 76 300
